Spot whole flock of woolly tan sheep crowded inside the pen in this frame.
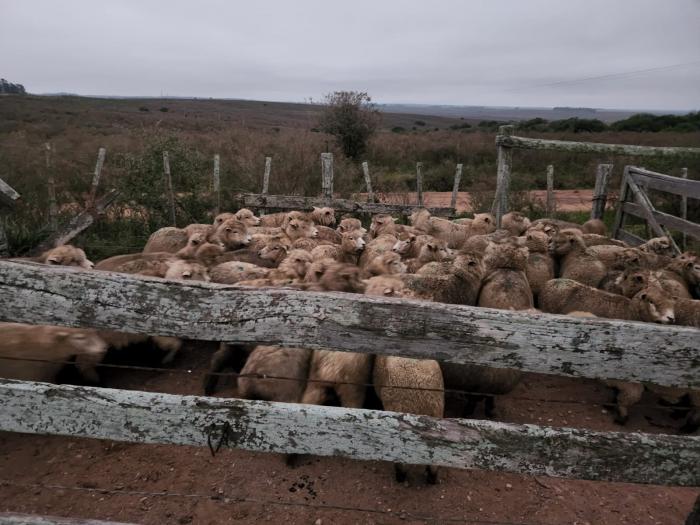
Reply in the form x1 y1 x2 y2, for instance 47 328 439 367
0 208 700 482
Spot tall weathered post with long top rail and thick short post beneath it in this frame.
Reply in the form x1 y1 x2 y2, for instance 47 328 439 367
491 126 700 226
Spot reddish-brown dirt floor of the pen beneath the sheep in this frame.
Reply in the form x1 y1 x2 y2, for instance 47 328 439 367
0 344 698 525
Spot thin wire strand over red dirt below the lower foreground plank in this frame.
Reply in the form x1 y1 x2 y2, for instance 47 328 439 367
0 479 544 525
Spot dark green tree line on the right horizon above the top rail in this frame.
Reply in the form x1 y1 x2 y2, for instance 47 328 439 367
477 111 700 133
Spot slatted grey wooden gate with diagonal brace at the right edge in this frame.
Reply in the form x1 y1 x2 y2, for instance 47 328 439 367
612 166 700 253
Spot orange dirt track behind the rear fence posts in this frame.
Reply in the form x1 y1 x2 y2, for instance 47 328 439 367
360 189 612 213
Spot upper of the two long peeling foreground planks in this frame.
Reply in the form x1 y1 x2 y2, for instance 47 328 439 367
0 261 700 388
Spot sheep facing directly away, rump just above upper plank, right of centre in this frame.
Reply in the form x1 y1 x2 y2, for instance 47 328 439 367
477 243 534 310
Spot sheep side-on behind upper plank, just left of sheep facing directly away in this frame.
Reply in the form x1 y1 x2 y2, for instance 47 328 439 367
400 253 484 306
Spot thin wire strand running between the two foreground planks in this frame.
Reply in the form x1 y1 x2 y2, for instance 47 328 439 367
0 356 692 412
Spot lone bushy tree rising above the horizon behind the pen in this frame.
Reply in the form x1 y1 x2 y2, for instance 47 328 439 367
318 91 380 159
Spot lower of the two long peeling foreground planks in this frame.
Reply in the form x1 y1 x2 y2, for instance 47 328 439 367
0 380 700 486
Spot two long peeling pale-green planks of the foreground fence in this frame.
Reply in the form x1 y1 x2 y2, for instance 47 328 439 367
0 261 700 486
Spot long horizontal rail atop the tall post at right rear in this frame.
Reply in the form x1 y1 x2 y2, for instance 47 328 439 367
496 133 700 157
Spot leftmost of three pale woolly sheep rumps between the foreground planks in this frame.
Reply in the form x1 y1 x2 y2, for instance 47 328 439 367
238 345 311 403
